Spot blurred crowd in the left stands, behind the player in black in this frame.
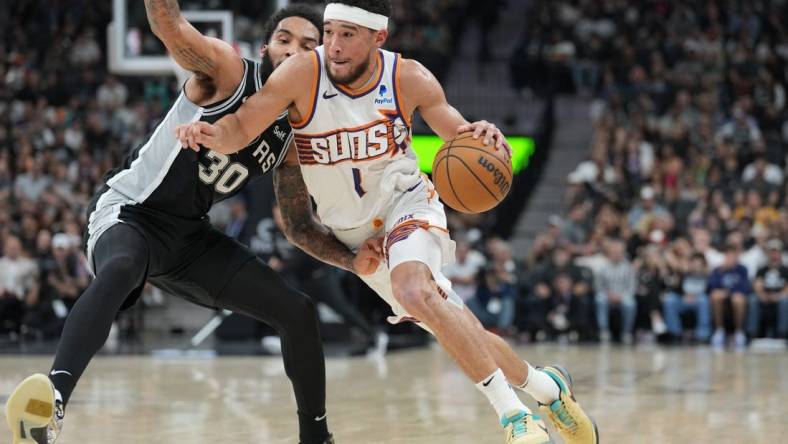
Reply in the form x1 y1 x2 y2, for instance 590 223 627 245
0 0 464 344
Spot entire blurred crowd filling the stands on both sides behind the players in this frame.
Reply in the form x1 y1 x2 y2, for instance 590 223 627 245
0 0 788 354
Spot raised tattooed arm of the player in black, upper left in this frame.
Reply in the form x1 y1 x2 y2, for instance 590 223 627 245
145 0 243 93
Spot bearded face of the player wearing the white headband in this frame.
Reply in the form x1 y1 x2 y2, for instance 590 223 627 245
323 20 388 85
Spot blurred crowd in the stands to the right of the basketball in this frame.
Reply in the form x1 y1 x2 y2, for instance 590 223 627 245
504 0 788 348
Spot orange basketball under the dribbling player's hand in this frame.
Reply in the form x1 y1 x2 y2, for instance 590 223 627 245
432 133 512 214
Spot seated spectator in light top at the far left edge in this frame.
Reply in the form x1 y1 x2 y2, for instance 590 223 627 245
0 236 39 332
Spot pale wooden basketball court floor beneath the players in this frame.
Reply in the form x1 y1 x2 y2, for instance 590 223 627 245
0 345 788 444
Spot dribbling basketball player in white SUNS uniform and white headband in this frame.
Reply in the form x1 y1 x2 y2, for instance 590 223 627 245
176 0 598 444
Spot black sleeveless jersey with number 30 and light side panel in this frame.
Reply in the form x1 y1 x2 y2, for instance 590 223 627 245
104 59 293 219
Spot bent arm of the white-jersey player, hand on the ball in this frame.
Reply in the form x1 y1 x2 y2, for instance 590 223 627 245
400 60 510 151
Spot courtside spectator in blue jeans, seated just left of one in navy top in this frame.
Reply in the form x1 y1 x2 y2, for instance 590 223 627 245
663 253 711 342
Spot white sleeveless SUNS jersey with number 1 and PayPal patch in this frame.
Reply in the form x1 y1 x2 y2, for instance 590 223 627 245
291 46 421 229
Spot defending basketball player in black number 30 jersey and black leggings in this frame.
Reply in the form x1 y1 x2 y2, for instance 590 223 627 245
6 0 376 444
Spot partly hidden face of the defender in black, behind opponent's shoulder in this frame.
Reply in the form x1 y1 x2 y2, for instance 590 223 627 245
260 16 320 69
